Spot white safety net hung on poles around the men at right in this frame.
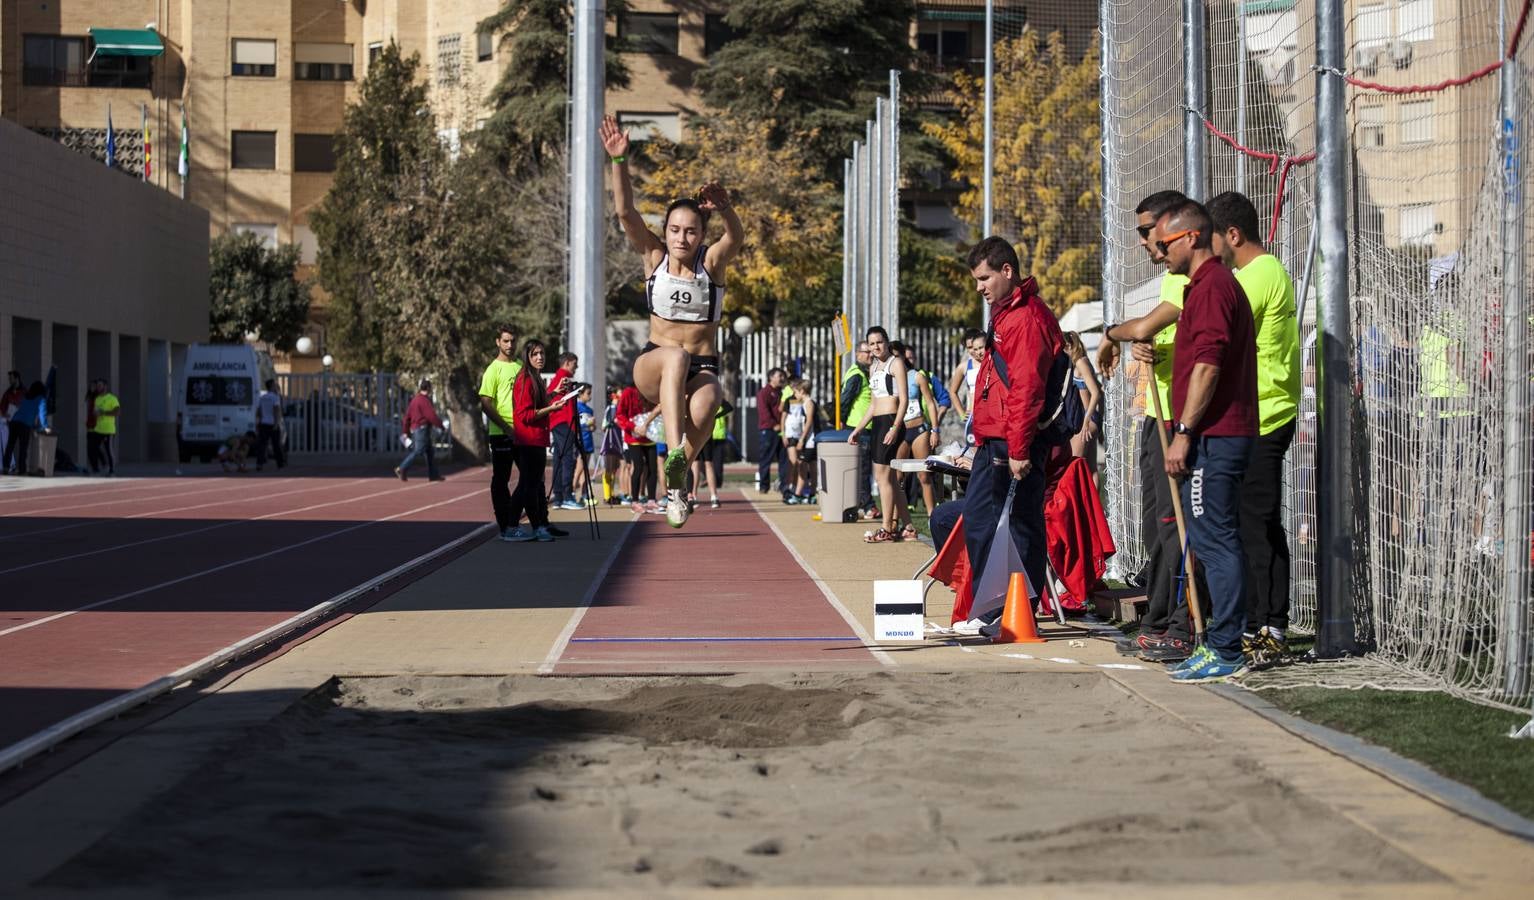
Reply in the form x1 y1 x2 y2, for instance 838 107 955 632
1101 0 1534 708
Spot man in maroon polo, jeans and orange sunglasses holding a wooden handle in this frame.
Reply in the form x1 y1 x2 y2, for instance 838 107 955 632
1154 201 1258 684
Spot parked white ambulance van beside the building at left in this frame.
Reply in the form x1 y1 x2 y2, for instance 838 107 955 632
176 343 276 463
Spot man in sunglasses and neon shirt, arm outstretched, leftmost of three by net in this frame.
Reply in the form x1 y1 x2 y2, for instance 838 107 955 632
1097 190 1209 662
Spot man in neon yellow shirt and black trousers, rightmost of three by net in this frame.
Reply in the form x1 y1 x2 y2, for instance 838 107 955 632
1209 190 1301 664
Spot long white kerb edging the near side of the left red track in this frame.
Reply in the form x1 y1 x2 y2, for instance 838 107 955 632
0 524 494 771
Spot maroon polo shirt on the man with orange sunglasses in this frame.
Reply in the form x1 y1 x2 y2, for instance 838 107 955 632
1172 259 1258 437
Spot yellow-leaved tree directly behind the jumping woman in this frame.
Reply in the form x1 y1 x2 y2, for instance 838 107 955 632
638 117 842 325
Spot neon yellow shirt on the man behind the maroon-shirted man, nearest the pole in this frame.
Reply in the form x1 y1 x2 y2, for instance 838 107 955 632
1236 253 1299 434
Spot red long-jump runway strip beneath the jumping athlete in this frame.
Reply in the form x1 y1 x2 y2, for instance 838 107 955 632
554 495 881 675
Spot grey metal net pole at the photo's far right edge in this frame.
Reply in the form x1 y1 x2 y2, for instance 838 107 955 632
1497 0 1531 696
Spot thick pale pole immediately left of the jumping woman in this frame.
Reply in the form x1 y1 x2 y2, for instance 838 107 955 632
569 0 607 400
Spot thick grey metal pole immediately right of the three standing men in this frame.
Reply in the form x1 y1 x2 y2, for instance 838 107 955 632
1315 0 1356 658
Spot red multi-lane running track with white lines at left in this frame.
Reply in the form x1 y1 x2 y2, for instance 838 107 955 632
0 471 489 747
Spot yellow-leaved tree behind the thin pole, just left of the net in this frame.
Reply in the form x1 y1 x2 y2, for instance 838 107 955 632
925 31 1103 314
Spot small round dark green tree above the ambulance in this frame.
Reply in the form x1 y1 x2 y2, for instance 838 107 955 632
209 232 308 351
